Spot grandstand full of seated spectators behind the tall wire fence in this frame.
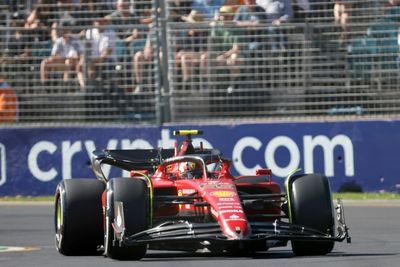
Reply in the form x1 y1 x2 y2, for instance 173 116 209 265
0 0 400 124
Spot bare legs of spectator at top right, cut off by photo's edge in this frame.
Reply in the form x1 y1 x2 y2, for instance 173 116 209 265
333 0 353 44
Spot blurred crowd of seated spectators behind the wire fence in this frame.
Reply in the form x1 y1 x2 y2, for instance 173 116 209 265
0 0 400 123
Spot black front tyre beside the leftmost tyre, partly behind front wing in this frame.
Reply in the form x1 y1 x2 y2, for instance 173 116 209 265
105 178 149 260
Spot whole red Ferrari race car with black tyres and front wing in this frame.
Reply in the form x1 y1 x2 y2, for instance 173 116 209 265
54 130 351 260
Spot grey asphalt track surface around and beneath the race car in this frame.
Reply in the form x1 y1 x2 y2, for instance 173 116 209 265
0 201 400 267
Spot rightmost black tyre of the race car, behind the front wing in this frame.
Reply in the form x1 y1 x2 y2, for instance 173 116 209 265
287 174 335 256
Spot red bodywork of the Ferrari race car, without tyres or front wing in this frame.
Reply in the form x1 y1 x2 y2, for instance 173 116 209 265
102 135 282 240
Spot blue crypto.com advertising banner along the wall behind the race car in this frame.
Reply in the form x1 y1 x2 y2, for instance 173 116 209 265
0 121 400 196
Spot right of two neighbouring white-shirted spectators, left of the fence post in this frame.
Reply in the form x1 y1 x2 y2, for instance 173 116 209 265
86 17 117 80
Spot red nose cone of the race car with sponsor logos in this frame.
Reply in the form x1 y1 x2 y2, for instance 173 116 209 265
203 186 249 239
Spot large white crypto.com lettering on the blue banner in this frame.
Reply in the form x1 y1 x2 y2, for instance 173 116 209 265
23 129 354 182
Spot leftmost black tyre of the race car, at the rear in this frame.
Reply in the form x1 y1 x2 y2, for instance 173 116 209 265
54 179 105 255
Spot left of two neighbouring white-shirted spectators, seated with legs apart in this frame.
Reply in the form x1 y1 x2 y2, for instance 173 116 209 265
40 22 85 88
